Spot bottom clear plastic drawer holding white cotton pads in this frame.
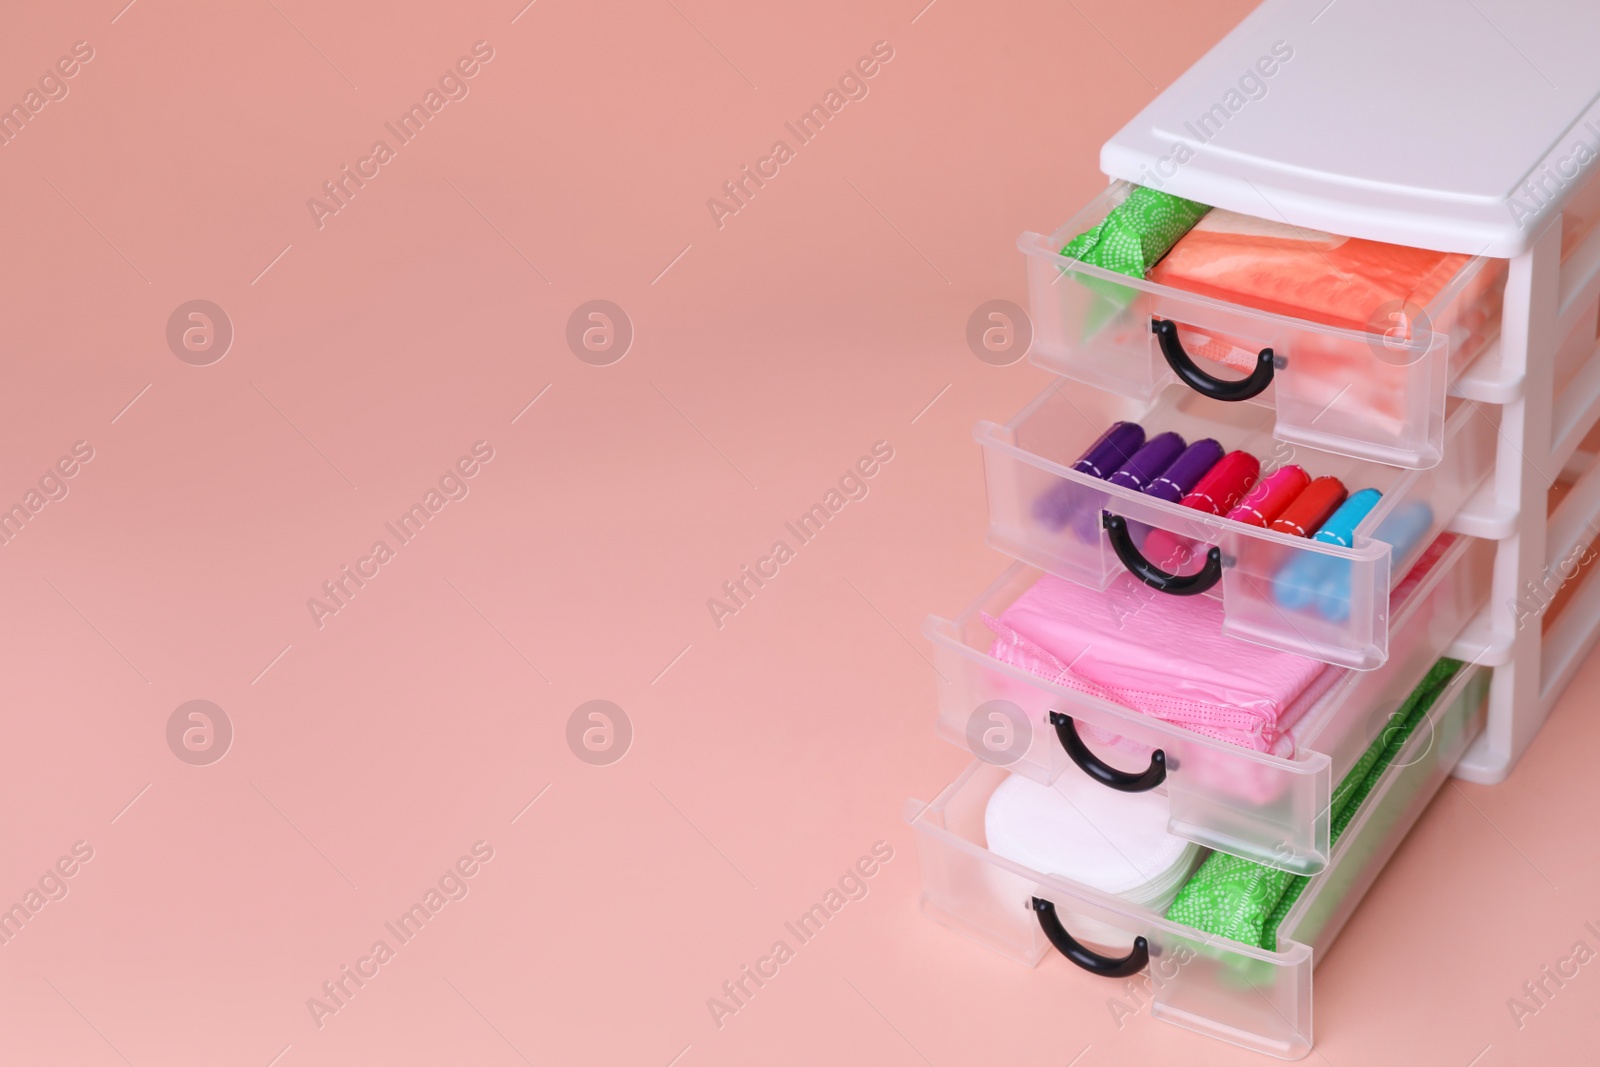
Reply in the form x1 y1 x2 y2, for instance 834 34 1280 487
906 667 1488 1059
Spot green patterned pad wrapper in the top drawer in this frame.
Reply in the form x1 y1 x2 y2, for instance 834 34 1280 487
1061 186 1211 341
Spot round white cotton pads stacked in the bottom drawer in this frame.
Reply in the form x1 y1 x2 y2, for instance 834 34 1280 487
984 769 1200 907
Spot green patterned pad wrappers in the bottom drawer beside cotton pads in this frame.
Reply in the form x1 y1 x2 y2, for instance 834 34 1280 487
1166 659 1462 952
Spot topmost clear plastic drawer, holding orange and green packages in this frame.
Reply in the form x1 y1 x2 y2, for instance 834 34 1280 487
1018 182 1506 469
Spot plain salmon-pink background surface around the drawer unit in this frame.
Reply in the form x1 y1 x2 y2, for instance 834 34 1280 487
0 0 1600 1067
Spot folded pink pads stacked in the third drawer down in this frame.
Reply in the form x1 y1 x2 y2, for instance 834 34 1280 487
984 574 1333 755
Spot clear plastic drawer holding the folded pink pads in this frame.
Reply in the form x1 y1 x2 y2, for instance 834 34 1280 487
923 537 1494 873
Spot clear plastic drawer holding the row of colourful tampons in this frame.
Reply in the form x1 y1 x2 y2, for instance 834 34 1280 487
973 382 1499 670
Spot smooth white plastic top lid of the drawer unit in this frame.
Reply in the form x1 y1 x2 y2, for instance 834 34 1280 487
1101 0 1600 258
